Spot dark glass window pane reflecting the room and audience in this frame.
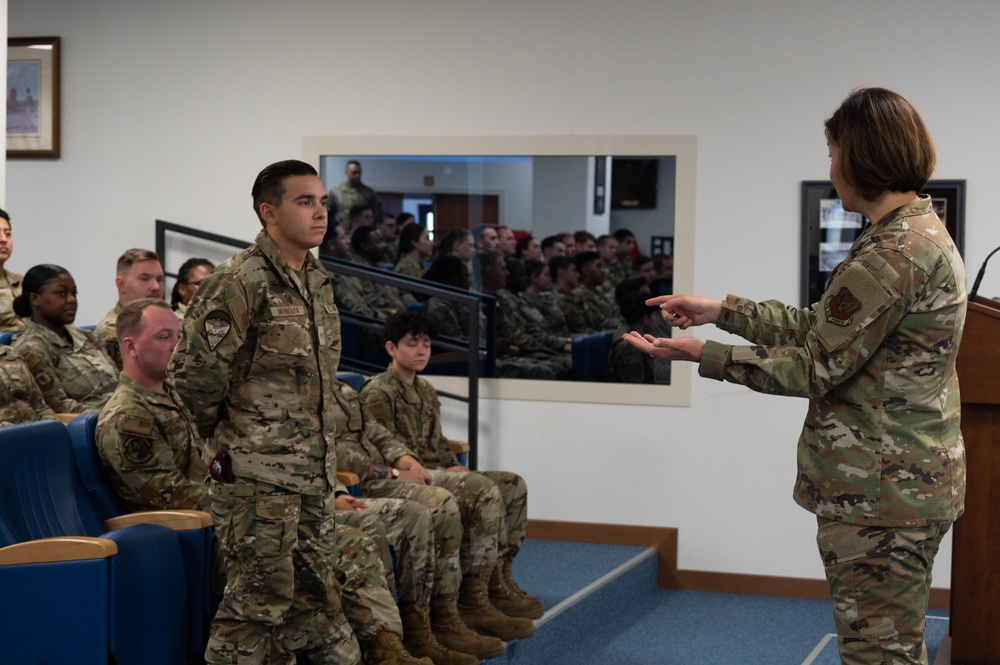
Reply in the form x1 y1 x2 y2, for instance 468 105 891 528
320 154 677 384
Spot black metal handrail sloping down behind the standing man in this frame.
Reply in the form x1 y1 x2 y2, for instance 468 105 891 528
156 219 488 469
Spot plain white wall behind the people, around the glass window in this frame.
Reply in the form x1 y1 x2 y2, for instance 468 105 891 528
7 0 1000 586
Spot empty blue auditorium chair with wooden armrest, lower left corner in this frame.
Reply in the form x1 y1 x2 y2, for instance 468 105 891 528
0 420 199 665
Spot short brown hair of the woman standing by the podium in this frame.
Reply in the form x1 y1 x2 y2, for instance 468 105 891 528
824 88 936 202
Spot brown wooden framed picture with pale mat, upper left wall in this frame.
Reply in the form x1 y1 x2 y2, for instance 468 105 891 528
7 37 59 159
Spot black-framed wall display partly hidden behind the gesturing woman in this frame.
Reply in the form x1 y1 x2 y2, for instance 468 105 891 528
801 180 965 307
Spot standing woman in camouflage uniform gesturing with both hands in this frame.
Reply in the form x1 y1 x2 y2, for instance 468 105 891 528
625 88 967 664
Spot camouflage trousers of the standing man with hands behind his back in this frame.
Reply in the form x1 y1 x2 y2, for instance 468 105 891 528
205 478 361 665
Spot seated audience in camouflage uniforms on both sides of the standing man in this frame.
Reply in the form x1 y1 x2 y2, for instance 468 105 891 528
0 188 544 665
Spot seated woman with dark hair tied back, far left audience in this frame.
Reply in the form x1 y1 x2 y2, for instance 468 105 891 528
13 264 118 413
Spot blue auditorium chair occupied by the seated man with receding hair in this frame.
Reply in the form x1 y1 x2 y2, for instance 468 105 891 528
66 411 218 656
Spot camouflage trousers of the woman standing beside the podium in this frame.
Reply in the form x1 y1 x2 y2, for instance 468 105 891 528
816 518 951 665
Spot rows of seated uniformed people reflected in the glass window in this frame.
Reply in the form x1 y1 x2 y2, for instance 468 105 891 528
308 193 673 382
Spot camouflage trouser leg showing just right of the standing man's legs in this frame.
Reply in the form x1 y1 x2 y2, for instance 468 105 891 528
333 513 403 649
